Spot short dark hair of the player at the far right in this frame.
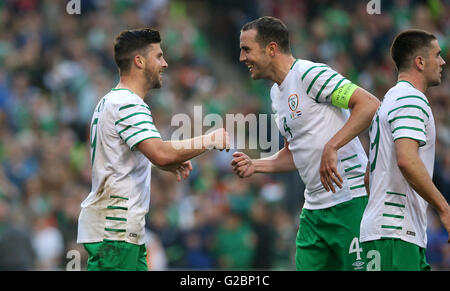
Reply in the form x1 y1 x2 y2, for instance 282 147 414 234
391 29 436 72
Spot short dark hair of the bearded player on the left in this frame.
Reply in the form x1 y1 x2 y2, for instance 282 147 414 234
114 28 161 74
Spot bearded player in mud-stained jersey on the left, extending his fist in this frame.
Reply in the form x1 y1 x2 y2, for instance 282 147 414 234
77 29 229 271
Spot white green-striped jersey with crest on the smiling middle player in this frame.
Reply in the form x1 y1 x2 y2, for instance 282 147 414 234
270 60 367 209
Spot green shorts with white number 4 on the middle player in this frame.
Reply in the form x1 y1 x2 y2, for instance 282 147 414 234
295 196 367 271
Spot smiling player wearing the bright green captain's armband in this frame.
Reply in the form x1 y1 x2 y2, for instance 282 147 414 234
231 16 379 270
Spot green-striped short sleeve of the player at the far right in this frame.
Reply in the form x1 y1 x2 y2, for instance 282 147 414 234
388 95 431 146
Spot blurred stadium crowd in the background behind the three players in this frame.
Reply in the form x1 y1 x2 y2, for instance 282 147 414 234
0 0 450 270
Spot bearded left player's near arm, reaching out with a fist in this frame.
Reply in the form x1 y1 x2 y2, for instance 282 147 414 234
137 128 229 168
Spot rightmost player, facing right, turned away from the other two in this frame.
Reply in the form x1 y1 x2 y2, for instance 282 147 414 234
361 30 450 271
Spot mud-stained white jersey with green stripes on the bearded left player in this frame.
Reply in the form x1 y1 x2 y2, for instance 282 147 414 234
77 89 161 244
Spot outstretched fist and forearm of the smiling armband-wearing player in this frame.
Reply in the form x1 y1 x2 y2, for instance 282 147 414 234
231 139 297 178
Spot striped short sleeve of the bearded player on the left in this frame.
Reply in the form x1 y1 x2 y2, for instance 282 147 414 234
114 104 161 150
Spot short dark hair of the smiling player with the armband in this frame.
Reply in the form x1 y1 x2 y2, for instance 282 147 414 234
241 16 291 53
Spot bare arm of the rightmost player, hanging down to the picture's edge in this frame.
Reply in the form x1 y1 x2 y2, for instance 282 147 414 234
395 138 450 242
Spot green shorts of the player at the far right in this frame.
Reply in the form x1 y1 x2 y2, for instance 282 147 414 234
361 238 431 271
